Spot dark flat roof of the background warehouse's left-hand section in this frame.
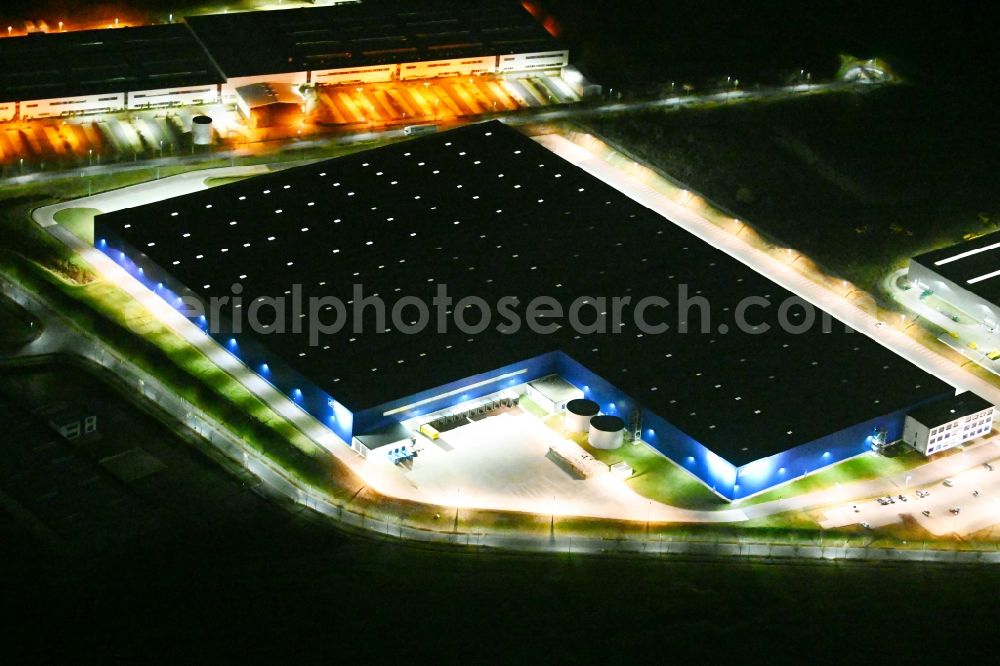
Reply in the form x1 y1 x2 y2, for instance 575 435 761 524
0 24 223 102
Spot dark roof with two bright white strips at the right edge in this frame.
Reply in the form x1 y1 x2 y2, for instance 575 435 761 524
913 231 1000 304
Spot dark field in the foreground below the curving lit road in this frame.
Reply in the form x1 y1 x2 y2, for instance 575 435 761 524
0 368 1000 663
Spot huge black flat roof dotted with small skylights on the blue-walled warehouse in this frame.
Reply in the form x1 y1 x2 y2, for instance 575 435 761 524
99 121 949 465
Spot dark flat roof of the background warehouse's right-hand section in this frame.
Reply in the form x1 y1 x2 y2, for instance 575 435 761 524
185 0 562 78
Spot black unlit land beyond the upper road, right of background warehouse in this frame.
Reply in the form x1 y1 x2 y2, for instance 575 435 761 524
537 0 996 94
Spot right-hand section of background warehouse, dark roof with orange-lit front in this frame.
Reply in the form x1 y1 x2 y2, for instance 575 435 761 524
187 0 569 95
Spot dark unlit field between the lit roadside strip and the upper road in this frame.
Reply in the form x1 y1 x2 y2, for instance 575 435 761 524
587 86 1000 289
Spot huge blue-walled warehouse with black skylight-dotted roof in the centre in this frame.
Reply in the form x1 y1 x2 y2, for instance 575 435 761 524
95 122 954 499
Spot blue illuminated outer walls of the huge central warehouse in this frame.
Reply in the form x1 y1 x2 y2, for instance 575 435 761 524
95 226 944 500
